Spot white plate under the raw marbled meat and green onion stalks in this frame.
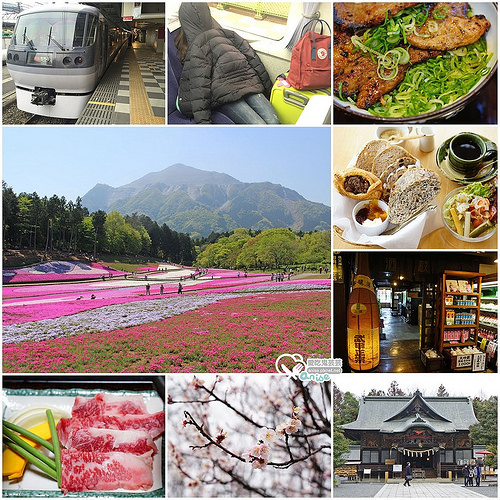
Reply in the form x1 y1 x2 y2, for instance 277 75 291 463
2 389 165 498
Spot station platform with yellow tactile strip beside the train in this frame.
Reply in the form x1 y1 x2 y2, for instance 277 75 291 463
76 42 165 125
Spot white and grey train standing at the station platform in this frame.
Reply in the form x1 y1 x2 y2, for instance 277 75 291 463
7 4 131 119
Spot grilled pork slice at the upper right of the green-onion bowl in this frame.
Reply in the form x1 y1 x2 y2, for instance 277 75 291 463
406 2 491 50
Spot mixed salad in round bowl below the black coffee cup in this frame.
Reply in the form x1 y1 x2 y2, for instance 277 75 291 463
441 181 497 242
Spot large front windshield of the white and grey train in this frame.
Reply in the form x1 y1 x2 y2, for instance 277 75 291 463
14 12 85 50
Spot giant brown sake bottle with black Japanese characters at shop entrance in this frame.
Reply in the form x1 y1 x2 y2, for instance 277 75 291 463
347 253 380 371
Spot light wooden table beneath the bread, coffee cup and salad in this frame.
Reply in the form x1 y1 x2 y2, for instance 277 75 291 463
332 125 498 250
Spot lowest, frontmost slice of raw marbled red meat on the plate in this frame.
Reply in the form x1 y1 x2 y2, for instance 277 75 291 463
61 449 153 494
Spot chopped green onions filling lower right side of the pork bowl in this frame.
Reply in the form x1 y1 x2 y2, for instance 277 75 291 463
368 37 492 118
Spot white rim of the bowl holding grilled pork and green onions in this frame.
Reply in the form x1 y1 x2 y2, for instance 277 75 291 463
333 2 498 123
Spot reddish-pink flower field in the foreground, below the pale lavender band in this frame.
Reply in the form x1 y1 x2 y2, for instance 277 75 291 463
3 290 331 373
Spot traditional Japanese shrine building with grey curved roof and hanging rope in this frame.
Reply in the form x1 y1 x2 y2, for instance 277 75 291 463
342 390 478 478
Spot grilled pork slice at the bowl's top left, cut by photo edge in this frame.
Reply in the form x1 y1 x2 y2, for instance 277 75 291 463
333 2 418 30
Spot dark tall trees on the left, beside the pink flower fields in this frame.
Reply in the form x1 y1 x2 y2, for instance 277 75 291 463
2 183 196 265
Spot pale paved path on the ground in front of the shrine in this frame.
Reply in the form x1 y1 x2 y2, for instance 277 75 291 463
375 482 485 498
